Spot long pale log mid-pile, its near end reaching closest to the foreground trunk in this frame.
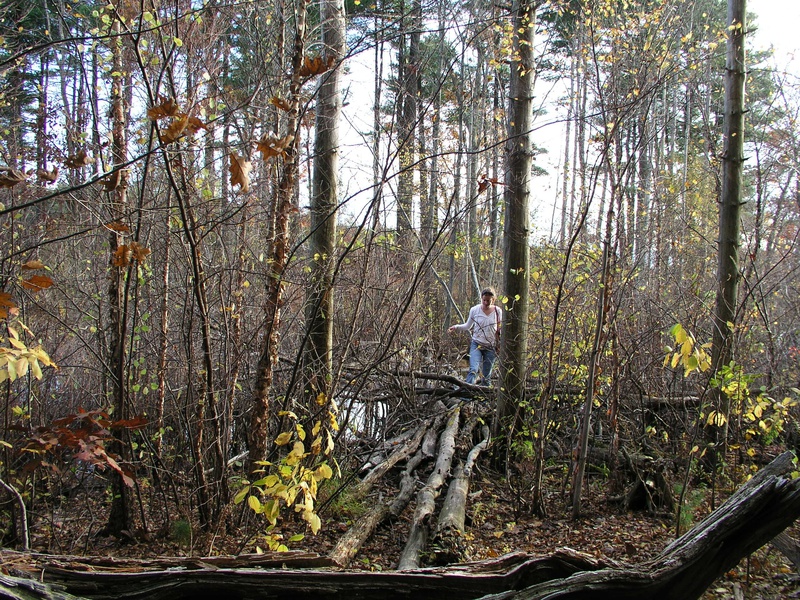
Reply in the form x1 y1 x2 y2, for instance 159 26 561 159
397 407 461 571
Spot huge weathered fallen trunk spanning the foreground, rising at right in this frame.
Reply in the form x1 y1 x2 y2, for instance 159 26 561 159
6 453 800 600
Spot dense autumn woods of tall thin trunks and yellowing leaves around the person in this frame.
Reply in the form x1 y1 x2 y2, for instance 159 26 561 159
0 0 800 596
